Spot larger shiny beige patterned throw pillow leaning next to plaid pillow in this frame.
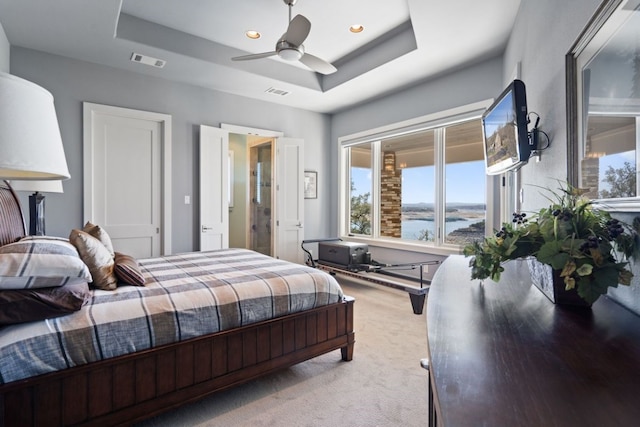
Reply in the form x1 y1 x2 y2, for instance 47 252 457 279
69 229 118 291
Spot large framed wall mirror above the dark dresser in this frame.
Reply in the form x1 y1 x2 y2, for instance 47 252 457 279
566 0 640 212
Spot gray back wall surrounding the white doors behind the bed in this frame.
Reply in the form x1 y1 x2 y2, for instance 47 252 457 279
11 47 331 252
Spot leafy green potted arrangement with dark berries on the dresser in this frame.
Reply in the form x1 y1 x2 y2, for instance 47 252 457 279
463 185 640 306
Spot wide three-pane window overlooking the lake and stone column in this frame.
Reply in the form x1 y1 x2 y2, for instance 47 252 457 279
340 106 488 248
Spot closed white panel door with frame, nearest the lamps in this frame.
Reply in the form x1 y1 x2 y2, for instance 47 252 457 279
84 103 170 258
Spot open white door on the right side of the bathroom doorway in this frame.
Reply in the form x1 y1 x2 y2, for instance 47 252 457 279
275 138 304 264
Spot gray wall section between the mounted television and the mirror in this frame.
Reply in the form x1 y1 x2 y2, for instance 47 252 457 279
504 0 601 211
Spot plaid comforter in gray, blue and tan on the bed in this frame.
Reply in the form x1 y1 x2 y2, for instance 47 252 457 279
0 249 342 383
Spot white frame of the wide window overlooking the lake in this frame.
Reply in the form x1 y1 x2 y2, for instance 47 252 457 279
338 99 492 255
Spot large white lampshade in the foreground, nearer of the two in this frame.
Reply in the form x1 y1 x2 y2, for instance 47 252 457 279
0 73 69 180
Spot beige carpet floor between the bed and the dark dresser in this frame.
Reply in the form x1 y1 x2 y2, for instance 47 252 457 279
137 276 428 427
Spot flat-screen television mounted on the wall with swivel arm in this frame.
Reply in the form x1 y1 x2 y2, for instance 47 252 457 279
482 80 535 175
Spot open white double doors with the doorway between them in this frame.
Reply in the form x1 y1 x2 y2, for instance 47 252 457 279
200 123 304 263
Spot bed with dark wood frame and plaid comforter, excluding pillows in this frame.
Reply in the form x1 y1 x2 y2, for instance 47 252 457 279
0 185 355 426
